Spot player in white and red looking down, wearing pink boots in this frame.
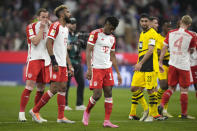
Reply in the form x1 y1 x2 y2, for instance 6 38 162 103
82 17 122 128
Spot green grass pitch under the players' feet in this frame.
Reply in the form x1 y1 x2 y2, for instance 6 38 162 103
0 86 197 131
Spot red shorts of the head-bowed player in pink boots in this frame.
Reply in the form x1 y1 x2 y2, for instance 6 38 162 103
90 68 114 90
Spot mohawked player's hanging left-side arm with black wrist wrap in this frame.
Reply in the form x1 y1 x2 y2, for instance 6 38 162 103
46 38 58 71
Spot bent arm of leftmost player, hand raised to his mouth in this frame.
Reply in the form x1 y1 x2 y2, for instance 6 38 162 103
31 22 46 46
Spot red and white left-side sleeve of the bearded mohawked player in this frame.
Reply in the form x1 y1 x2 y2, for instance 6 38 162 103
47 23 60 40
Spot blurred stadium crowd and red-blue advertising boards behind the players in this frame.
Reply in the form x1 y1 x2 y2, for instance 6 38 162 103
0 0 197 87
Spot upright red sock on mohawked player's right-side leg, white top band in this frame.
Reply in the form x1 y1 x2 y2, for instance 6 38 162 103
57 92 65 119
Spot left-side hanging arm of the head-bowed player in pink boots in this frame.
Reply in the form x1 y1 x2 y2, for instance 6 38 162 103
86 44 94 80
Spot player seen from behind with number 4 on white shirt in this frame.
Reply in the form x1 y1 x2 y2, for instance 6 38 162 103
158 15 196 119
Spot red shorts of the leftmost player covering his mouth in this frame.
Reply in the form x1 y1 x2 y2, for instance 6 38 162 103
26 60 45 83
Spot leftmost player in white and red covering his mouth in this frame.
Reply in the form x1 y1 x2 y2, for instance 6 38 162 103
18 8 50 122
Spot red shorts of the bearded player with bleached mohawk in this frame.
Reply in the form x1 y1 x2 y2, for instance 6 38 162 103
51 66 68 82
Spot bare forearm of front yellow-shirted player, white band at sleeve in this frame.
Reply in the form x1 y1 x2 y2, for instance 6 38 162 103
134 39 155 71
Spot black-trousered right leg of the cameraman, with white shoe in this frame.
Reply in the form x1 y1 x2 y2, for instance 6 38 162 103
74 64 86 110
